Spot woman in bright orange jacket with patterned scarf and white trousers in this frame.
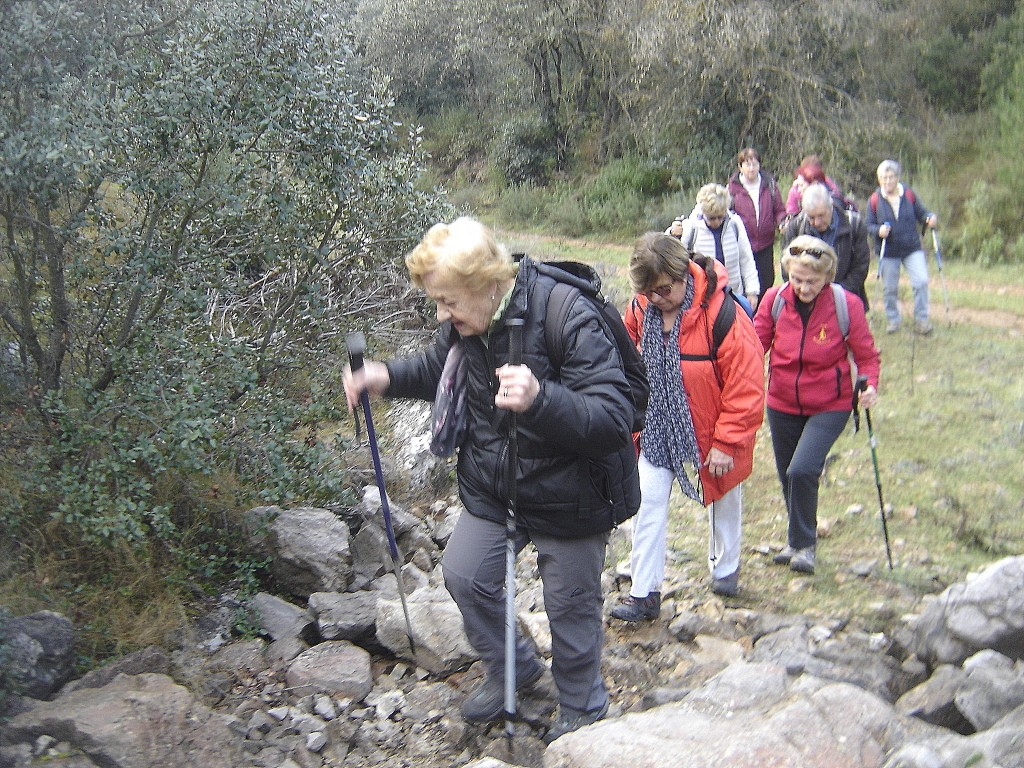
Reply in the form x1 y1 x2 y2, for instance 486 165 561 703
611 232 764 622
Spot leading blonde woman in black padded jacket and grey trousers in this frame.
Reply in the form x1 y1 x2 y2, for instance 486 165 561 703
345 217 640 741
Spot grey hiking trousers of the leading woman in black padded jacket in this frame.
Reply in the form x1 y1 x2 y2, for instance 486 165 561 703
441 512 608 716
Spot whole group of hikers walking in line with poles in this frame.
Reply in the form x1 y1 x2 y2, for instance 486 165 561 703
344 148 936 743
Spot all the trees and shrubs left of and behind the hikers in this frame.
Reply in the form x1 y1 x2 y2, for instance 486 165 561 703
0 0 1024 684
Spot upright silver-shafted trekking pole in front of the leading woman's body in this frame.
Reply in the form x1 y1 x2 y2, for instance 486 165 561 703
505 317 525 753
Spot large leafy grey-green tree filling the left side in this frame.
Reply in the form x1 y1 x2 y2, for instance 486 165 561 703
0 0 444 547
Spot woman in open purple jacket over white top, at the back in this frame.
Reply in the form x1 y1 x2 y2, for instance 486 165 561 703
729 146 785 305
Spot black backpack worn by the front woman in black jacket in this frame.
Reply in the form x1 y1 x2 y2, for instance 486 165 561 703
537 261 650 432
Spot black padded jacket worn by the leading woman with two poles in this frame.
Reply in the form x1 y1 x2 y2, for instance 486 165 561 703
385 257 640 538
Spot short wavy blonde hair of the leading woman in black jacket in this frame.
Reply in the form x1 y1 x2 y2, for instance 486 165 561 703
406 216 516 292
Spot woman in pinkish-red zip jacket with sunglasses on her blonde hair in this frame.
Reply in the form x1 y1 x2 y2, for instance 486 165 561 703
754 234 880 573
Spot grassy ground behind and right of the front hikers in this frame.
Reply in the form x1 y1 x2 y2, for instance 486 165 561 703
501 232 1024 630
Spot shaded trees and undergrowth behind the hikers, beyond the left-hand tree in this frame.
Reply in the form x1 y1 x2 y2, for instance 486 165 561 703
362 0 1024 261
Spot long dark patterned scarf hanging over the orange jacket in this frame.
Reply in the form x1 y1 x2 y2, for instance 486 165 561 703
640 278 700 503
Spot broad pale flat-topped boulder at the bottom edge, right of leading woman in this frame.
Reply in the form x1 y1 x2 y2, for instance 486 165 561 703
545 663 931 768
